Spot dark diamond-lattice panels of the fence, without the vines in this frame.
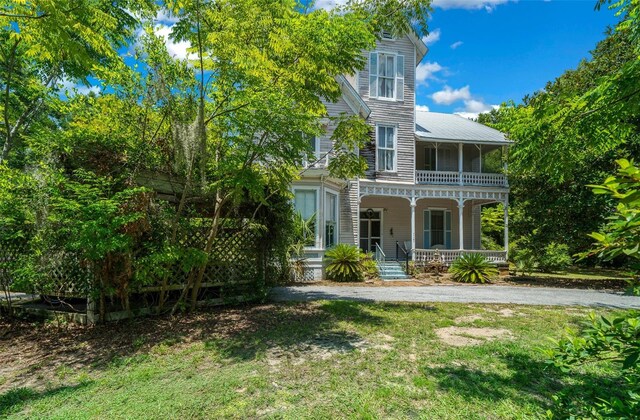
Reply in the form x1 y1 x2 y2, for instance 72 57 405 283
0 219 281 308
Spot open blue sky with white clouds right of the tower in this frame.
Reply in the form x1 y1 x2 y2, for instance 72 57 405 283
416 0 617 117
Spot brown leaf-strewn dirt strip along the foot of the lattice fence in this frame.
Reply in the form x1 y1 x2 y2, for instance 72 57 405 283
0 304 330 393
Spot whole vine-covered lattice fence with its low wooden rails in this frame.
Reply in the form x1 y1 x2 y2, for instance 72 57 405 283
0 219 284 322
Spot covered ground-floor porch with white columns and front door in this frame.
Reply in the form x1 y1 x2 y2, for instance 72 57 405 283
358 187 508 264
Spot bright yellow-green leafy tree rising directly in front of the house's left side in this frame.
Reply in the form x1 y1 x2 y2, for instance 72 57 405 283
148 0 428 307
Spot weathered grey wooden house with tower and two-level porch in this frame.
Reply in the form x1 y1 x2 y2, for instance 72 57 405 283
293 34 510 279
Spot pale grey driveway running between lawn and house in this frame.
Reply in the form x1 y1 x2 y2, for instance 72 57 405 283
270 285 640 309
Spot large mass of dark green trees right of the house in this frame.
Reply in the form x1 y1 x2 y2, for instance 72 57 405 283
479 1 640 260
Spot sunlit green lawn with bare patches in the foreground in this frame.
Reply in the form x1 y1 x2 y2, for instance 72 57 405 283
0 301 615 419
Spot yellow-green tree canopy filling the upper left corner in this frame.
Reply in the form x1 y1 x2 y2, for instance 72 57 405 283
0 0 156 163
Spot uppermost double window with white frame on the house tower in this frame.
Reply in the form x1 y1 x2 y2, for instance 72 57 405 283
369 52 404 101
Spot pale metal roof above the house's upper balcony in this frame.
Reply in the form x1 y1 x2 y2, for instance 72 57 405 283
416 110 513 145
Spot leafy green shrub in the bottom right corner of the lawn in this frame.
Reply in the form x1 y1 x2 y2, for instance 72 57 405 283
546 311 640 419
